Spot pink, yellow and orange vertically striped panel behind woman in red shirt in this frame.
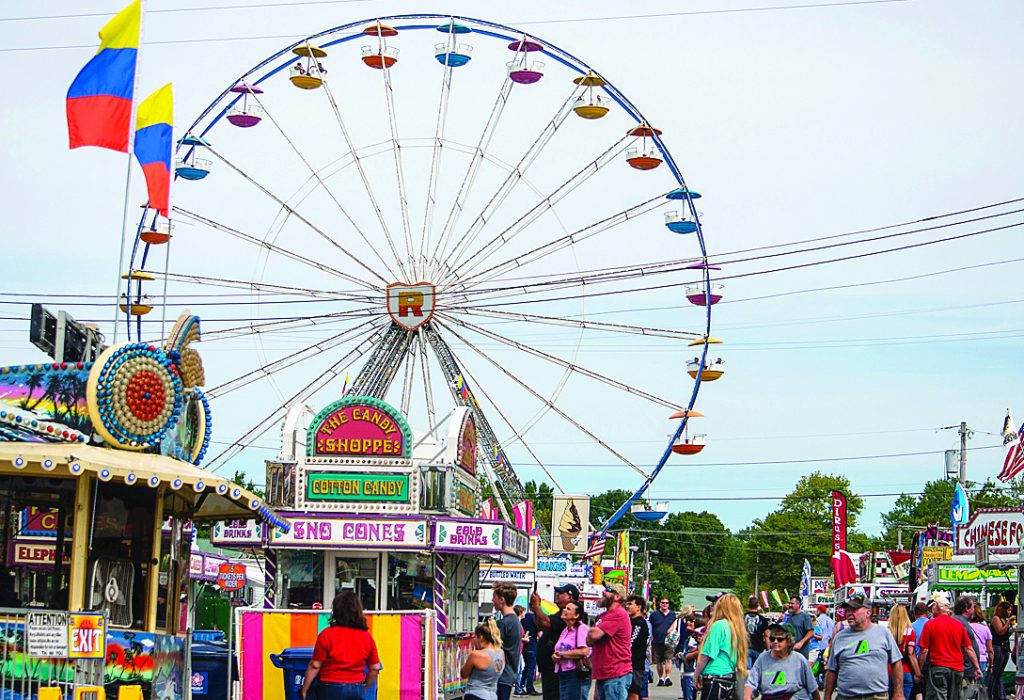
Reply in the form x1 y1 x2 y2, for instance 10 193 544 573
239 610 434 700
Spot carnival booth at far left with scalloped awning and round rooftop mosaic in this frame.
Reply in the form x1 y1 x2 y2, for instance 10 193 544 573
0 314 287 700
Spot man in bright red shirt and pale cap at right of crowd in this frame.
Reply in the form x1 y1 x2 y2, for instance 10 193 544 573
918 594 981 700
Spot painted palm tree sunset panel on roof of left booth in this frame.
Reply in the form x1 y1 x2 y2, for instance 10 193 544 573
0 362 92 442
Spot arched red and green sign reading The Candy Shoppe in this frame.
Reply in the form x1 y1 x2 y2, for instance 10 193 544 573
306 396 413 458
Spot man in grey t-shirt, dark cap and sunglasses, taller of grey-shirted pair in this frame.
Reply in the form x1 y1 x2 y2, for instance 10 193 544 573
824 594 903 700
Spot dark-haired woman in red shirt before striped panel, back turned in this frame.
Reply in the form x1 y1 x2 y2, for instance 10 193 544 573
301 590 380 700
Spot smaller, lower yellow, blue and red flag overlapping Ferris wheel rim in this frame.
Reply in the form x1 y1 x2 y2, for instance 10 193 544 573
134 83 174 216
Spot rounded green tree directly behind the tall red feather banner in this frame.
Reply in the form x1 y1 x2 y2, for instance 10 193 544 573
740 472 871 595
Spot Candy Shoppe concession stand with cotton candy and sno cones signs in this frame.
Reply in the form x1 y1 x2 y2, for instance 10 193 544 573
219 396 529 700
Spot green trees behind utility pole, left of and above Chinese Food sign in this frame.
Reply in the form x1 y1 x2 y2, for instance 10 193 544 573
882 479 1024 546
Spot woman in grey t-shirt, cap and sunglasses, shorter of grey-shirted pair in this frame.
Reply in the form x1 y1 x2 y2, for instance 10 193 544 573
743 623 821 700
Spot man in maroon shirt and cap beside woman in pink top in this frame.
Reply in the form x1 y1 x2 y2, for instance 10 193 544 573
587 583 633 700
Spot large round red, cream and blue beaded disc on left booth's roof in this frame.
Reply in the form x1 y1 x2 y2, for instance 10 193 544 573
86 343 184 449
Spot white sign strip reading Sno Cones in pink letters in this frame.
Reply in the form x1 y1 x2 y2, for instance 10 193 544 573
271 517 427 549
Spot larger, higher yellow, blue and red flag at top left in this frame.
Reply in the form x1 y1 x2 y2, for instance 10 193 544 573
67 0 142 154
